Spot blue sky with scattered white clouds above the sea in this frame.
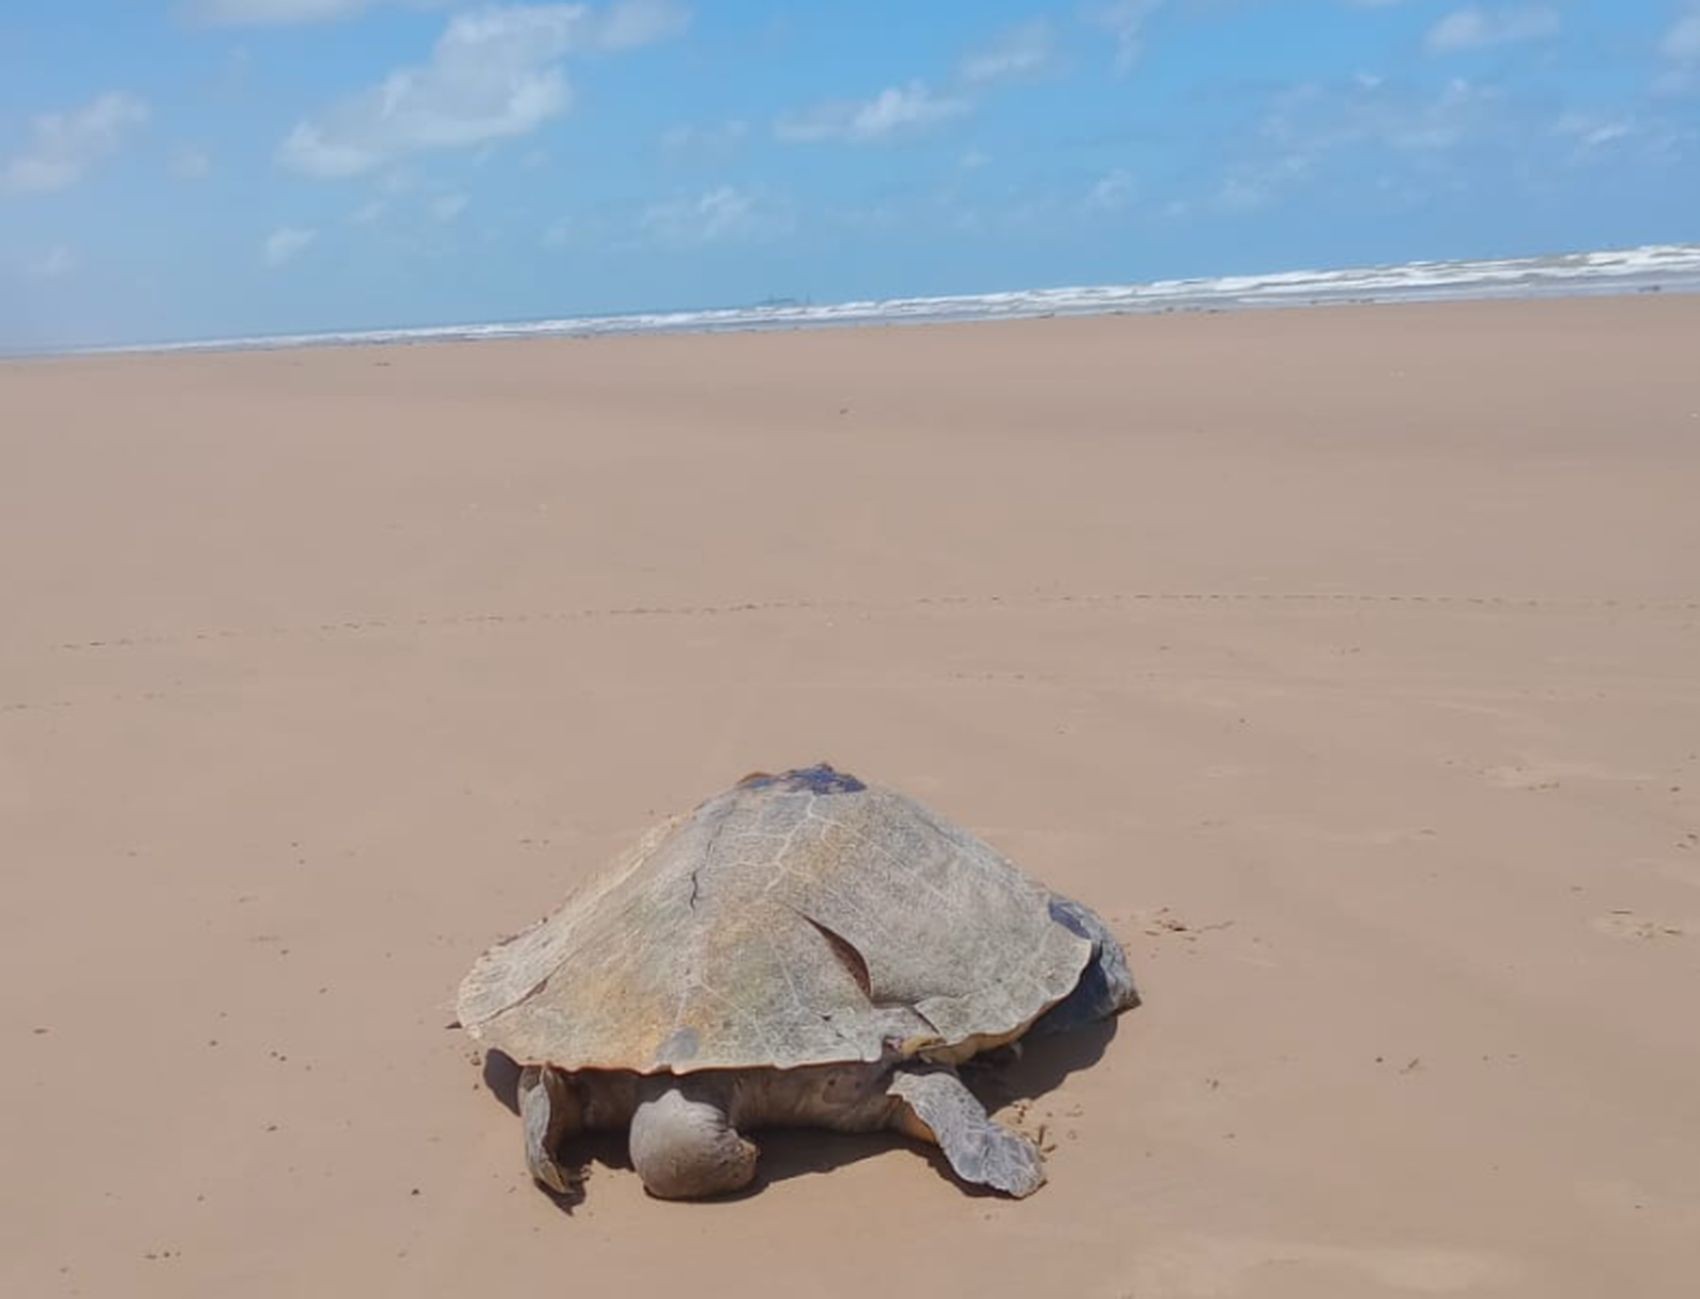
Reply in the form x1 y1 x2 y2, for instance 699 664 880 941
0 0 1700 347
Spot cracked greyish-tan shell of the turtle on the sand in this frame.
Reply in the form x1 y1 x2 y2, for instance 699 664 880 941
457 765 1093 1073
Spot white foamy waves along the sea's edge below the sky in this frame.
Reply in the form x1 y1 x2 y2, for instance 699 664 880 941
59 245 1700 352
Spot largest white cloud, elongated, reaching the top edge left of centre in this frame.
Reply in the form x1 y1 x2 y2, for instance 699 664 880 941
279 0 682 177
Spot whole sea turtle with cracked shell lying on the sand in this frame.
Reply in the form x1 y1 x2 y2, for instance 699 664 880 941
457 763 1137 1199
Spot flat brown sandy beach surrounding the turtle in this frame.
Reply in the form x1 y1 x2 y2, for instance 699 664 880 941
0 298 1700 1299
